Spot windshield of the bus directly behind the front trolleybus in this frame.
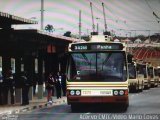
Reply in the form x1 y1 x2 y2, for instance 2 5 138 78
128 64 136 79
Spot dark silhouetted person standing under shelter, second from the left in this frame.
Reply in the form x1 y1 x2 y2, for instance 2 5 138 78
20 72 30 105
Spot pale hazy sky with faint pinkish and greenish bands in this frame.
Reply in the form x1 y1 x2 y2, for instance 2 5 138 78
0 0 160 37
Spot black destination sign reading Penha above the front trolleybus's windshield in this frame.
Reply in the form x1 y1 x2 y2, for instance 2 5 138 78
71 43 123 51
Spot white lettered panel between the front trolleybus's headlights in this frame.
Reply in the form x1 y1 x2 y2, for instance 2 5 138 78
81 90 113 96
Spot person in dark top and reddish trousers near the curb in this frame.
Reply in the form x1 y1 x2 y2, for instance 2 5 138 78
46 73 55 102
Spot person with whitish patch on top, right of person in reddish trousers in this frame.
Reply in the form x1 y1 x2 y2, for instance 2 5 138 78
55 72 61 99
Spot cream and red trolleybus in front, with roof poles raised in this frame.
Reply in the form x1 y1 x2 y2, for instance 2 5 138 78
67 35 129 111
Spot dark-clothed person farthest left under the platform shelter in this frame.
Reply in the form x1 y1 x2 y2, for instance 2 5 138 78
4 69 15 104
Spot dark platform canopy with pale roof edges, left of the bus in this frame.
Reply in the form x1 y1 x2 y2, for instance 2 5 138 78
0 12 78 56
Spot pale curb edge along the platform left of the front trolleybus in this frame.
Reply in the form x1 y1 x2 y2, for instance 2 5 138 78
0 100 67 117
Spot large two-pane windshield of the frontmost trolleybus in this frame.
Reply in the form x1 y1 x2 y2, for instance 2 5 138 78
68 51 127 82
